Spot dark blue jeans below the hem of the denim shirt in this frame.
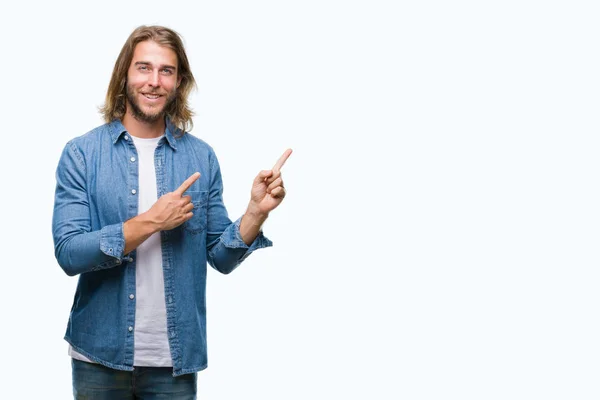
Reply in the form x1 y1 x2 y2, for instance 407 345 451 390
72 359 197 400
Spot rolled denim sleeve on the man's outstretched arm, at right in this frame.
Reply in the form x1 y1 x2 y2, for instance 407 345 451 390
206 153 273 274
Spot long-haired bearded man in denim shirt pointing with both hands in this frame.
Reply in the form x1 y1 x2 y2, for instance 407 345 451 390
52 26 291 399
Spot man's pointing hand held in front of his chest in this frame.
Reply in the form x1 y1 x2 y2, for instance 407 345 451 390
147 172 200 231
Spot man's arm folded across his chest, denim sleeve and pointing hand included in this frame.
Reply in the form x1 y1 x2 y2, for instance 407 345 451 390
52 142 200 276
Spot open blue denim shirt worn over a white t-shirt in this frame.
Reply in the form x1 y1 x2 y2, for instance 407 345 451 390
52 119 272 376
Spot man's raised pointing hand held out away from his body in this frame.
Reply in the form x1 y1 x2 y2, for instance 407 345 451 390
248 149 292 216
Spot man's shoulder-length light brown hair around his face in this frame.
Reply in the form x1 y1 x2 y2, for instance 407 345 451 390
100 25 196 136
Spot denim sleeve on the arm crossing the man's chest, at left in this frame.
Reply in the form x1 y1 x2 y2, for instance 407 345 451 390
52 142 125 276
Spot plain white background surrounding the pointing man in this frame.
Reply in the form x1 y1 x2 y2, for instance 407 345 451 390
0 0 600 400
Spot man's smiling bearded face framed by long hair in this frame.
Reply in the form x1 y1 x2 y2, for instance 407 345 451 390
126 40 181 123
